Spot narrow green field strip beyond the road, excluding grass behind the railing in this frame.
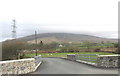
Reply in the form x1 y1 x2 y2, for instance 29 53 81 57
25 52 116 58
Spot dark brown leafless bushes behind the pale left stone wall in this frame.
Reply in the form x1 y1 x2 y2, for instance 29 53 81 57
2 41 25 60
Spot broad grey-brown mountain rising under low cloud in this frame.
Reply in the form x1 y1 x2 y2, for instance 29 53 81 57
17 33 118 43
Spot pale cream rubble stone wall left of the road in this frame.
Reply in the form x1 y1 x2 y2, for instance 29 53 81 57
0 58 35 74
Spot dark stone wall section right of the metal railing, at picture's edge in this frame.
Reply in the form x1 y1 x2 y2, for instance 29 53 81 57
97 55 120 67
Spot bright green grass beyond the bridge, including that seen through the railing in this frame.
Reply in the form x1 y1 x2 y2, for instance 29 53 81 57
25 52 117 63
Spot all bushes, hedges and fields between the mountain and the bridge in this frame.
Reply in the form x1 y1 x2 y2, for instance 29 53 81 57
2 40 120 60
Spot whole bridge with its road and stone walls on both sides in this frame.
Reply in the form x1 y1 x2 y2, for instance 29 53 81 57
0 54 120 76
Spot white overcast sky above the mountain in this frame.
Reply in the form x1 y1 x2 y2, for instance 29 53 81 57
0 0 120 41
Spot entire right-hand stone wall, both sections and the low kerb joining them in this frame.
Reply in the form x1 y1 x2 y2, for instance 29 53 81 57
67 54 120 68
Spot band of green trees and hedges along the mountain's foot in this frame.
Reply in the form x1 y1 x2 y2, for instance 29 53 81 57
26 41 117 52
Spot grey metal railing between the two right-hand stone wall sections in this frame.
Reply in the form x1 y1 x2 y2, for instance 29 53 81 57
76 54 98 63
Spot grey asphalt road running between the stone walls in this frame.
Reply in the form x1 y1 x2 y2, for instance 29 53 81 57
31 58 118 74
